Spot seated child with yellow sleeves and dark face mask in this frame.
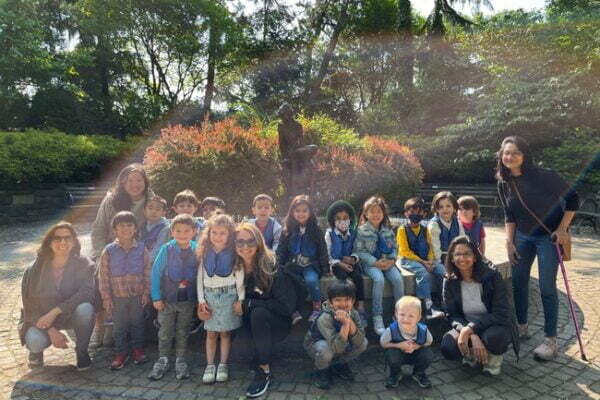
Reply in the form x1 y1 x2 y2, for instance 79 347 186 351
396 197 445 317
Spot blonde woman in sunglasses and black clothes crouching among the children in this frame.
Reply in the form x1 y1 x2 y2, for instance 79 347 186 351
235 223 307 397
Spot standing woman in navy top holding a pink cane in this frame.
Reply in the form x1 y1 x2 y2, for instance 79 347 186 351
496 136 579 360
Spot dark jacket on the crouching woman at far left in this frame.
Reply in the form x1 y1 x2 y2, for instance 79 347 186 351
18 255 94 344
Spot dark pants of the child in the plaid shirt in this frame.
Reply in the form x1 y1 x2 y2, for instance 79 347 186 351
112 296 144 353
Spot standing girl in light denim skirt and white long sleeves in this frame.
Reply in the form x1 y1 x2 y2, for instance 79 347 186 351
197 214 245 384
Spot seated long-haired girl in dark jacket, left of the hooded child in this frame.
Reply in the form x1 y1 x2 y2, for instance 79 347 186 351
277 195 329 323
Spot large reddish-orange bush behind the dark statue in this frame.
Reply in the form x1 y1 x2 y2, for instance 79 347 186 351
145 116 423 214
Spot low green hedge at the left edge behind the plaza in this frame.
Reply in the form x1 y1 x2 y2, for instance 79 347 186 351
0 130 139 188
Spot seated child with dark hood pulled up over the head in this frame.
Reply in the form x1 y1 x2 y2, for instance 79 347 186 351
325 200 368 328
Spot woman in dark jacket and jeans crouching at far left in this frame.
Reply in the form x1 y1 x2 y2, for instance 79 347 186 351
19 221 94 370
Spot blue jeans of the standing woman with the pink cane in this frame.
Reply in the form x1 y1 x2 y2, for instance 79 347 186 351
512 230 558 337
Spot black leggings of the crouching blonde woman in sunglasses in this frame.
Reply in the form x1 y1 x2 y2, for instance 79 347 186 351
244 307 292 365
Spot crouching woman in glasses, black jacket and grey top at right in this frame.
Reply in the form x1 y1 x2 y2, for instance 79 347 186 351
440 236 517 375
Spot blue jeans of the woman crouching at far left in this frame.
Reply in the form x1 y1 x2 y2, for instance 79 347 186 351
25 303 94 354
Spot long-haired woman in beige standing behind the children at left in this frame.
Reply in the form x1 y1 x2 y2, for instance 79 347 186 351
91 163 153 346
